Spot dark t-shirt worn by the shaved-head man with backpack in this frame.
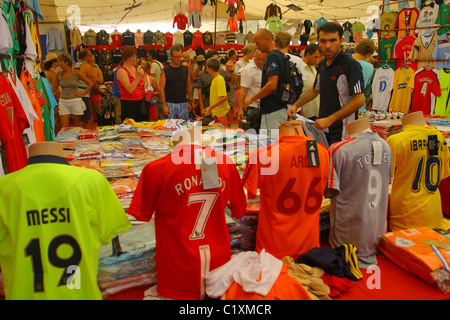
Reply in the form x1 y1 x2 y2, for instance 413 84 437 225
260 50 286 114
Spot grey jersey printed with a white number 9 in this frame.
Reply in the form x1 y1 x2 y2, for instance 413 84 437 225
325 132 392 267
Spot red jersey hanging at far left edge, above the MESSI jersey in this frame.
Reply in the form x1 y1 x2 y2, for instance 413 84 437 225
0 72 30 173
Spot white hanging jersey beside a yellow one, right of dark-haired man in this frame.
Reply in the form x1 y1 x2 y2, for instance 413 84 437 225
372 65 395 111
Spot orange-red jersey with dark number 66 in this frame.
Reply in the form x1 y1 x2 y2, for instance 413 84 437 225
242 136 330 259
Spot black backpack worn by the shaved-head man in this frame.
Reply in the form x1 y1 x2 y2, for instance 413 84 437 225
275 50 303 104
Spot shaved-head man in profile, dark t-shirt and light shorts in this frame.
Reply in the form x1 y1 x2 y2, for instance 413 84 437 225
241 29 288 135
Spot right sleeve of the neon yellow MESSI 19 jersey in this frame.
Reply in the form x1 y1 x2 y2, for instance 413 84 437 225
90 170 131 244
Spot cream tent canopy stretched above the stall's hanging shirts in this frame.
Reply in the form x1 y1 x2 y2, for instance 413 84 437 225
39 0 382 31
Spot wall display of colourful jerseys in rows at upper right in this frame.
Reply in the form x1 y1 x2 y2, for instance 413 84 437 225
372 1 450 116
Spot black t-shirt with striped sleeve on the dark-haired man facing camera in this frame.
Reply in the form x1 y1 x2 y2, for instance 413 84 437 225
314 50 364 144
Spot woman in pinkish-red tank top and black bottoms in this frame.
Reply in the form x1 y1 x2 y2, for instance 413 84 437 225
117 46 148 121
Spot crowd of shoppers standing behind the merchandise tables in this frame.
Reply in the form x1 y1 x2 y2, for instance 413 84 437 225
45 22 376 142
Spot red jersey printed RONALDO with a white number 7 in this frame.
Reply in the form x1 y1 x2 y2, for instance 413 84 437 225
128 145 246 299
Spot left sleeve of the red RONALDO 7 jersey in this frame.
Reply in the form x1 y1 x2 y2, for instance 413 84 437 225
127 165 159 221
